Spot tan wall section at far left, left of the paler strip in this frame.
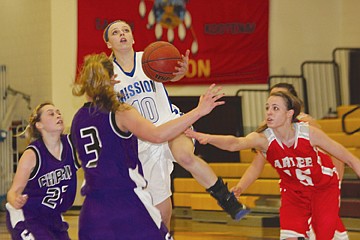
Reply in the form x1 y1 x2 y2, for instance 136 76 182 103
0 0 52 122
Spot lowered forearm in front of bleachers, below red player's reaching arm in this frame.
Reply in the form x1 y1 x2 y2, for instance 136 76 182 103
231 152 266 197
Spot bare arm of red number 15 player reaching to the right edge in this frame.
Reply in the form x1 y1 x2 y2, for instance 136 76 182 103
310 126 360 177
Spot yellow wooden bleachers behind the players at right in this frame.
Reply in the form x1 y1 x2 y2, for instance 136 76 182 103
173 105 360 231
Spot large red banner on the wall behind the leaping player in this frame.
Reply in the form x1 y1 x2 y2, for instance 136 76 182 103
78 0 269 84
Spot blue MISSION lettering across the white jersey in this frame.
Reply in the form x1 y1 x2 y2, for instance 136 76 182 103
119 80 156 102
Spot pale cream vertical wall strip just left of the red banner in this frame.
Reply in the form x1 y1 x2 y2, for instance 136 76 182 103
51 0 83 125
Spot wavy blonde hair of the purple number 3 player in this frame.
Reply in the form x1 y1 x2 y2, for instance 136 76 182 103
72 53 128 112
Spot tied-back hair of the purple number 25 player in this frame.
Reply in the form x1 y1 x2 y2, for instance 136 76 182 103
15 102 54 142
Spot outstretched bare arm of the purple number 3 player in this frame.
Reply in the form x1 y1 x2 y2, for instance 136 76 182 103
116 84 225 143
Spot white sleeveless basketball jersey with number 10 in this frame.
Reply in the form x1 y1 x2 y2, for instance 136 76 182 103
114 52 180 125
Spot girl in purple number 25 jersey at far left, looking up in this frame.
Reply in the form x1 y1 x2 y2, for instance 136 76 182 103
6 103 80 240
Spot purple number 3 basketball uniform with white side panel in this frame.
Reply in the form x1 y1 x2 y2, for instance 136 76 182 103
71 103 171 240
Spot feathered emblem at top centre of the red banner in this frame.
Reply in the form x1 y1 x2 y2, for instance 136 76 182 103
139 0 198 54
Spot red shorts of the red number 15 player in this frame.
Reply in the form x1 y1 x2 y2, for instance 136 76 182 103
280 184 340 240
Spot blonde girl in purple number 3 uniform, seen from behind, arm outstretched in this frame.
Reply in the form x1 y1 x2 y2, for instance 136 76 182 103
71 54 224 240
